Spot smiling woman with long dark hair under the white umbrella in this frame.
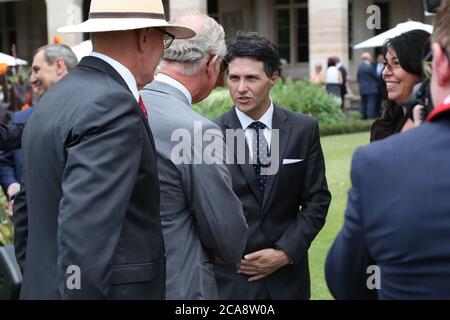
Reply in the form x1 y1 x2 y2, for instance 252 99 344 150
370 30 430 141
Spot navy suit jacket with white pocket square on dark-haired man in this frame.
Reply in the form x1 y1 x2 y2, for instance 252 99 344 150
215 106 331 299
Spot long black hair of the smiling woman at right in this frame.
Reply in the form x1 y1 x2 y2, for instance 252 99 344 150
370 30 430 141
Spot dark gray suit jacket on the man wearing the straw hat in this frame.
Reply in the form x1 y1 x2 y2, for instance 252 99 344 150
14 57 165 299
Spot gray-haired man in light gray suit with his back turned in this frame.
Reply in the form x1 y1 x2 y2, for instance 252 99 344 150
141 15 247 299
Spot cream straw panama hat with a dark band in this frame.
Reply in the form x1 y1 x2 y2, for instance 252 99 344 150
57 0 195 39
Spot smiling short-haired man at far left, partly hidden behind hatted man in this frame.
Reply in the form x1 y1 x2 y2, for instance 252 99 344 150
0 44 78 217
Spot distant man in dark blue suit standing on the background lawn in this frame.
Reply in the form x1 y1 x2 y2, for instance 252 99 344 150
357 52 378 119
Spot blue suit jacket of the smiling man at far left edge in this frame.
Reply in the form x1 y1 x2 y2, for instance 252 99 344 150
0 108 33 191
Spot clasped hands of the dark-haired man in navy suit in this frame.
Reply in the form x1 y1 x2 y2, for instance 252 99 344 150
238 249 291 282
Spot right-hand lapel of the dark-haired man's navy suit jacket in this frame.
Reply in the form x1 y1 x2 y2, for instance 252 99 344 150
261 106 291 212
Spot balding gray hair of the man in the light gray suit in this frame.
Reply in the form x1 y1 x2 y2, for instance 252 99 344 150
162 14 227 75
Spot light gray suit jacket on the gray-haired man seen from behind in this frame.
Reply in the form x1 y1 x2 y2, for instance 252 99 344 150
141 81 247 299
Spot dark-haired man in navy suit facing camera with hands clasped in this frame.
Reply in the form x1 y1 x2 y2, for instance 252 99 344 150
215 33 331 300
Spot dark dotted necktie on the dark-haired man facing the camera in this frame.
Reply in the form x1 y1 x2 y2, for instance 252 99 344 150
248 121 269 193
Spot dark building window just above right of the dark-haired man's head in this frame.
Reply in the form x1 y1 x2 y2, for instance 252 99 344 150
274 0 309 64
